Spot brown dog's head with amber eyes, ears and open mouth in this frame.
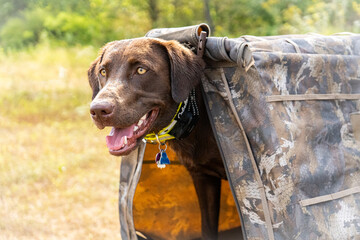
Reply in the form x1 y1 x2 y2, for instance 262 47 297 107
88 38 204 155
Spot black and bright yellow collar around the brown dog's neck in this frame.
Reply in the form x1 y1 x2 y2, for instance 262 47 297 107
144 89 199 143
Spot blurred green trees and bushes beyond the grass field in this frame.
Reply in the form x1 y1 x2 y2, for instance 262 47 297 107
0 0 360 49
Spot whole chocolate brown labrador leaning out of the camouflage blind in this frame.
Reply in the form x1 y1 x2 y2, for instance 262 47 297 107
88 38 226 239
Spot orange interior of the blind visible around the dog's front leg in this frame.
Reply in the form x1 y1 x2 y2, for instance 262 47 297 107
133 144 240 240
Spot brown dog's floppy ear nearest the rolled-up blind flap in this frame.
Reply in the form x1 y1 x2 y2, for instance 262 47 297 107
164 41 205 103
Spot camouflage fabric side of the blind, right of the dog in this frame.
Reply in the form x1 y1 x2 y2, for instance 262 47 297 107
202 35 360 240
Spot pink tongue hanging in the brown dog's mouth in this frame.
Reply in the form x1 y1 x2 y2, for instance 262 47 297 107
106 124 135 150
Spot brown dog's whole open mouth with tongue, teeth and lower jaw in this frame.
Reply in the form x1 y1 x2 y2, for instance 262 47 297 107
106 108 159 156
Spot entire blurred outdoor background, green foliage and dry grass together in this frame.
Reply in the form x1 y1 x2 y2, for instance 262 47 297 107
0 0 360 240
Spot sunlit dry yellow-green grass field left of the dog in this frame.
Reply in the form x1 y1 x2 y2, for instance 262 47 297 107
0 46 120 240
